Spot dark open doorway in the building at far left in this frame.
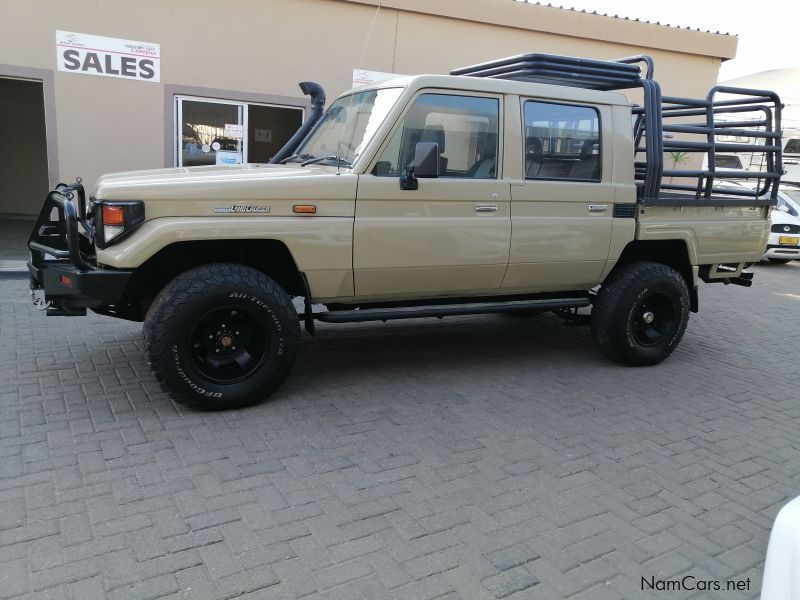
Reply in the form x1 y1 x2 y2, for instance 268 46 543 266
0 78 49 261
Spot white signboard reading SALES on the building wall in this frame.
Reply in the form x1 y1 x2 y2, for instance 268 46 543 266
56 31 161 81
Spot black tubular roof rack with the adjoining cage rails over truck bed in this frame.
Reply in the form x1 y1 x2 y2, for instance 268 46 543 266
450 54 783 206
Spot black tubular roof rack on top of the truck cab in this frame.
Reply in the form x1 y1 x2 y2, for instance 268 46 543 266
450 54 653 90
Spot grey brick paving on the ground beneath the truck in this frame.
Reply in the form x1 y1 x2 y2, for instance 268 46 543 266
0 264 800 600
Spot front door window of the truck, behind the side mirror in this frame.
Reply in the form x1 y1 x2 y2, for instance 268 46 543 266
375 94 499 179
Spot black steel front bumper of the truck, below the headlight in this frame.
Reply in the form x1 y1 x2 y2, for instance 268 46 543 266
28 260 132 316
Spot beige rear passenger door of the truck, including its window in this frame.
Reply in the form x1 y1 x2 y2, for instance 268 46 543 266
503 98 615 293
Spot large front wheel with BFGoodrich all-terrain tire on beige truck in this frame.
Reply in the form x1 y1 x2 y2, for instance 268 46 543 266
144 263 300 410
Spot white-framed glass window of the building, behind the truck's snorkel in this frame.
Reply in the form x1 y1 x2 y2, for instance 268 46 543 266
175 96 303 167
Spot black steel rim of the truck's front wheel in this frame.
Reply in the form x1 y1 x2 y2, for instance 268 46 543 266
188 305 271 385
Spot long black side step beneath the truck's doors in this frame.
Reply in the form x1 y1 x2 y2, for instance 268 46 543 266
314 297 592 323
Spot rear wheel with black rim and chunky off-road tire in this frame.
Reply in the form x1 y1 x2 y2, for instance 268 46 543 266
591 261 690 366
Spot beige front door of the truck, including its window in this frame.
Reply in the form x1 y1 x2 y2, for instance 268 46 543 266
353 93 511 300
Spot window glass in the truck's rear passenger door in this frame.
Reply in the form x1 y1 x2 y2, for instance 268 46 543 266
525 101 602 181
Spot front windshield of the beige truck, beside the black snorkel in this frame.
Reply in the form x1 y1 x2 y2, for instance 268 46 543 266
291 88 403 166
